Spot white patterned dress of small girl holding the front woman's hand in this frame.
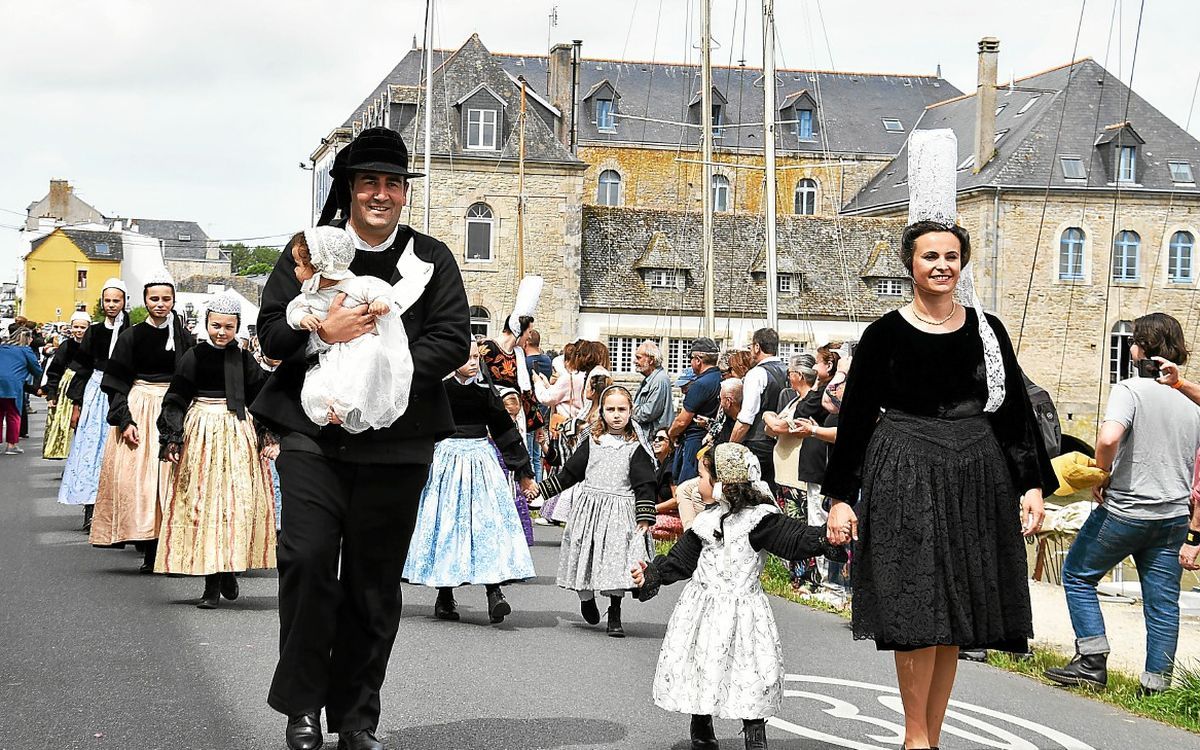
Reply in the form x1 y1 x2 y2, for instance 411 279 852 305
654 504 784 719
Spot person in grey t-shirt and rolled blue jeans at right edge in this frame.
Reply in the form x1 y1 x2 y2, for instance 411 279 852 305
1045 313 1200 692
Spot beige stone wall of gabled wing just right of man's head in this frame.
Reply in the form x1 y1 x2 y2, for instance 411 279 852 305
402 160 583 349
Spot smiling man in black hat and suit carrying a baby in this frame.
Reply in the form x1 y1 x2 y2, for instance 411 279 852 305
251 127 470 750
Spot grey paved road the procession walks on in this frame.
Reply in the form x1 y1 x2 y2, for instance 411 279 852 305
0 414 1200 750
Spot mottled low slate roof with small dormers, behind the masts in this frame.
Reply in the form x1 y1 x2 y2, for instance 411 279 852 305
580 205 905 318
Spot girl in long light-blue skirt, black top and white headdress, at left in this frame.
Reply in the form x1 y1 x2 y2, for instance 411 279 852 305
59 278 128 530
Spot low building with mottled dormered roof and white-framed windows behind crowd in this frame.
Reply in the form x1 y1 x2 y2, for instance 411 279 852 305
580 205 912 376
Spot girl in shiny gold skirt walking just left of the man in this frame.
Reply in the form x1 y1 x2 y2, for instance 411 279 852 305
154 295 275 608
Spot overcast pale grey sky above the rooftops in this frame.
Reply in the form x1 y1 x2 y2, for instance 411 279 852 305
0 0 1200 280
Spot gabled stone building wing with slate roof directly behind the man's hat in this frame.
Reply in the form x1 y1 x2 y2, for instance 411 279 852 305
312 35 587 346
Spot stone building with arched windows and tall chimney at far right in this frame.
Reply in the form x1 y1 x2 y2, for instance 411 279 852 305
844 38 1200 443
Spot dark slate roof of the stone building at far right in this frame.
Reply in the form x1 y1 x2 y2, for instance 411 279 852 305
842 59 1200 214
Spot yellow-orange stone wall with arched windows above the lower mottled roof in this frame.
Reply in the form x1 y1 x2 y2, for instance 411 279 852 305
578 145 889 216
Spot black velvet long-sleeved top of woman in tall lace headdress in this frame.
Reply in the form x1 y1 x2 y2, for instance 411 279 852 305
821 307 1058 504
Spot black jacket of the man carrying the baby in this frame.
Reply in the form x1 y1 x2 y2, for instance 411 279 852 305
251 226 470 464
